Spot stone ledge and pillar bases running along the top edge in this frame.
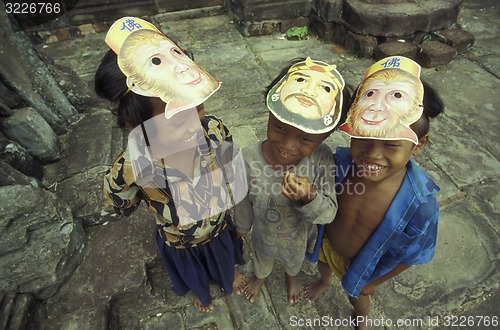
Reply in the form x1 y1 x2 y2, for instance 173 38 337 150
8 0 474 67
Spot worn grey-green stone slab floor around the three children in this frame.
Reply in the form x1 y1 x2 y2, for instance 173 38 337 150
32 0 500 330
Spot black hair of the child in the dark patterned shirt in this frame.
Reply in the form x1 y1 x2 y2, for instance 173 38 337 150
94 50 153 128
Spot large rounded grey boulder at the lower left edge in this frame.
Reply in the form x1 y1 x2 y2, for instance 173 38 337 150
0 185 85 299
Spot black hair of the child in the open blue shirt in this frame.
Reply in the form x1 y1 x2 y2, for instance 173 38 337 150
410 80 444 139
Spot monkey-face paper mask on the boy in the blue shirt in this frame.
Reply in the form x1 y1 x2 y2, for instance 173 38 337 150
340 56 424 144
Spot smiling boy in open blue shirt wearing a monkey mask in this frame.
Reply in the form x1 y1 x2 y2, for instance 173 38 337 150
305 56 443 328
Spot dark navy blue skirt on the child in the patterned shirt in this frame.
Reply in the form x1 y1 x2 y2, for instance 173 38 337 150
155 220 245 306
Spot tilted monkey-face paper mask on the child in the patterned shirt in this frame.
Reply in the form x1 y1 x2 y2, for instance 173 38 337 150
105 17 220 118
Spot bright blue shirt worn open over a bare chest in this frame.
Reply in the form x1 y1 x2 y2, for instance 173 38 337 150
310 147 440 298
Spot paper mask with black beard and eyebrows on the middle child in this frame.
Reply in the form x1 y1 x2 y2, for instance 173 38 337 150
266 57 345 134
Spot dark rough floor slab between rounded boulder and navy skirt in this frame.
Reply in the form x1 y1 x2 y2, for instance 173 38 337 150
46 206 158 322
